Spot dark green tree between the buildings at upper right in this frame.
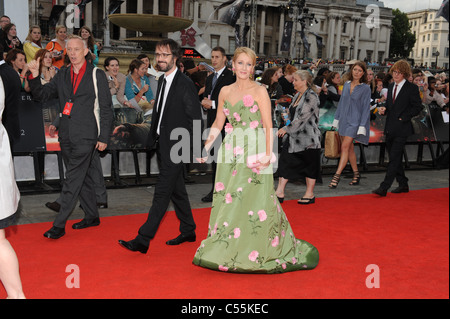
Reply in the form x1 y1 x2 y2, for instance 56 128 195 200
389 9 416 58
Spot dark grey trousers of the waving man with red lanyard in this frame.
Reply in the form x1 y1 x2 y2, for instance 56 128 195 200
53 141 100 228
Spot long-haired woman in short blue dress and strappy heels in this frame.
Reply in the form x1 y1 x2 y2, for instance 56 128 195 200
328 61 371 188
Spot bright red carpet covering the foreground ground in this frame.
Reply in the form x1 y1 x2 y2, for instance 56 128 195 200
0 188 449 299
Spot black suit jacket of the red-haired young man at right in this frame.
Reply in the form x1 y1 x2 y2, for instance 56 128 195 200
384 81 423 137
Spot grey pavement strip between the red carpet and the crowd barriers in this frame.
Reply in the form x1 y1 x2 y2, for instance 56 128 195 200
17 168 449 225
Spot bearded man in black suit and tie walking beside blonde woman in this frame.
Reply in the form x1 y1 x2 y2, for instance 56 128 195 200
119 39 201 254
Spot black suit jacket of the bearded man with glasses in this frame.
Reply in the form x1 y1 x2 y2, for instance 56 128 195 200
147 70 202 161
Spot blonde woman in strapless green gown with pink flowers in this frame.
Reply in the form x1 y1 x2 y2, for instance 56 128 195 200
193 47 319 273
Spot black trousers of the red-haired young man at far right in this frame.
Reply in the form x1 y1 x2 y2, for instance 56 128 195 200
380 135 408 190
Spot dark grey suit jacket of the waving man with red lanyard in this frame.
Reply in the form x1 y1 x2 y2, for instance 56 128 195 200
29 63 113 144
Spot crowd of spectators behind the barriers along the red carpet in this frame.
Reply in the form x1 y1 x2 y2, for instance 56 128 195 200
0 16 449 178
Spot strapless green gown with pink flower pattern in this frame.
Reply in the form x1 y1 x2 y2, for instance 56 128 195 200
192 95 318 272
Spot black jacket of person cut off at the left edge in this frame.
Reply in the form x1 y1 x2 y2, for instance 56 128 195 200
0 63 22 148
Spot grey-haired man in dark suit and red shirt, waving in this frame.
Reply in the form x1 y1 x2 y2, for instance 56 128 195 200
28 36 113 239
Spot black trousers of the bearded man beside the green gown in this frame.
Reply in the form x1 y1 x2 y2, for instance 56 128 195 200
136 149 196 246
